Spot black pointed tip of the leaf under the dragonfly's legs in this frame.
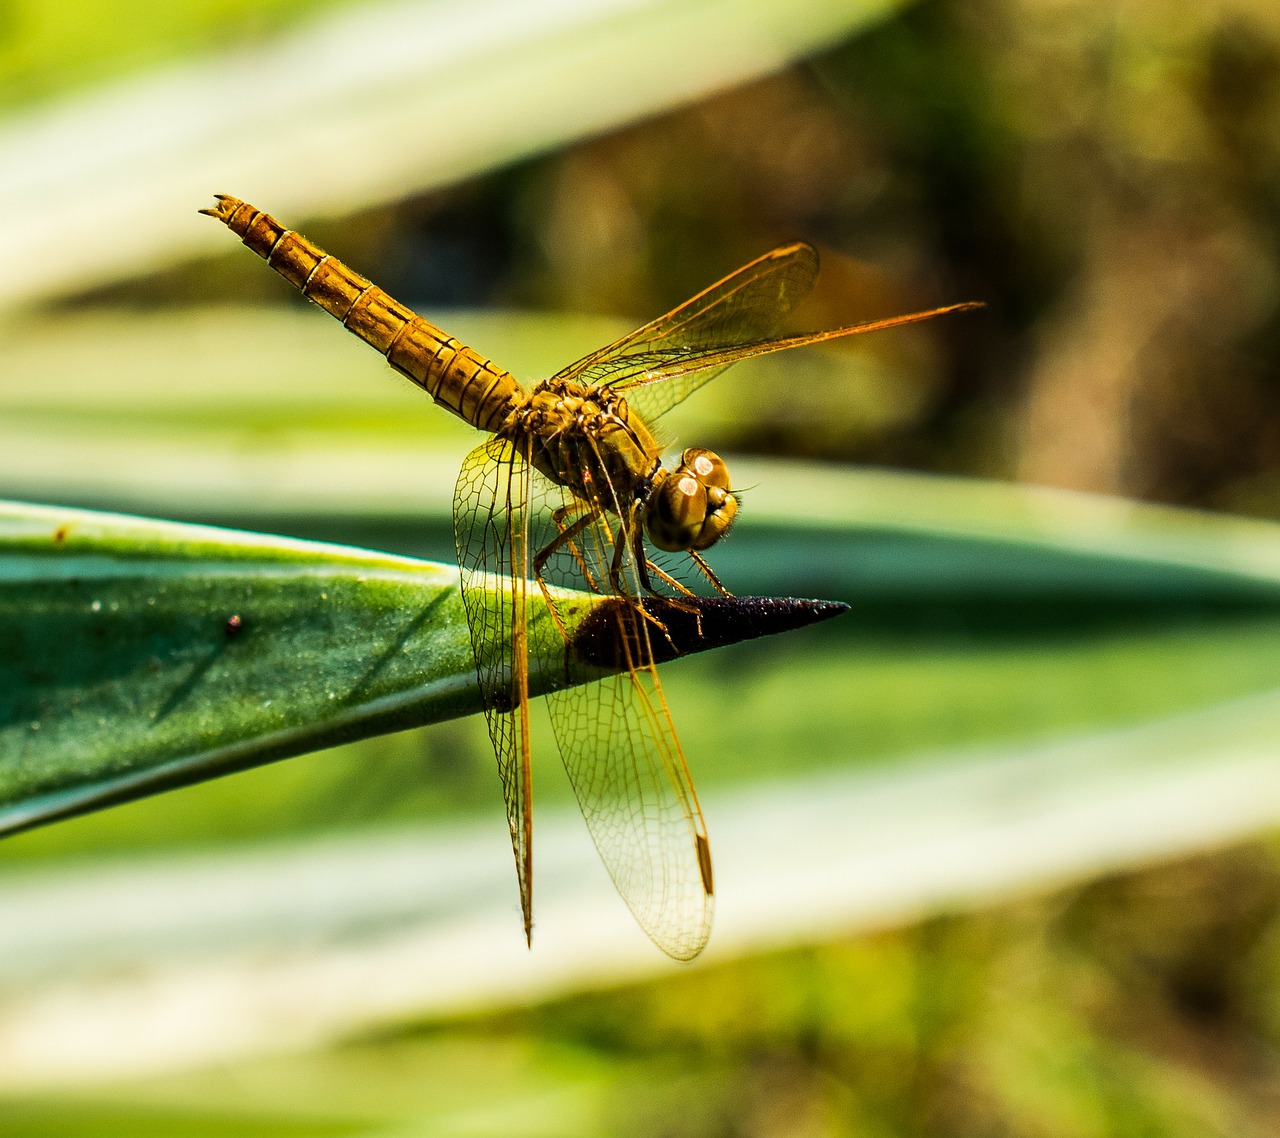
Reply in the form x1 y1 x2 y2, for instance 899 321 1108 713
570 597 849 671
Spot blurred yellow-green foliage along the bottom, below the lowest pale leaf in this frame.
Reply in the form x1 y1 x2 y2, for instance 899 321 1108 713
10 842 1280 1138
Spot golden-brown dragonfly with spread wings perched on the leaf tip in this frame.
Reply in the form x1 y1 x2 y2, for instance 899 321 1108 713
201 195 977 960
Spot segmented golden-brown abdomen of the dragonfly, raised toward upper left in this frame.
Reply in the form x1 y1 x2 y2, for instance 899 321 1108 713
201 193 520 431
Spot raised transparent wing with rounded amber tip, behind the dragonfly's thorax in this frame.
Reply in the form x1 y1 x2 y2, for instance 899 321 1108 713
557 242 818 417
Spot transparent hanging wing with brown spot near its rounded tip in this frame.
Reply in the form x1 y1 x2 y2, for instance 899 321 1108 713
531 435 714 960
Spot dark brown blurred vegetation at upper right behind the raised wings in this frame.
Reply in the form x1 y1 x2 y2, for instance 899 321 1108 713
237 0 1280 515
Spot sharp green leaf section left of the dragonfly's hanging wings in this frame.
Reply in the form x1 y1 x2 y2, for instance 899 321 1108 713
0 503 479 832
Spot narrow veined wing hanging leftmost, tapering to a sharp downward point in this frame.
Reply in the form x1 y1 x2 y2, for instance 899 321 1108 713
453 438 534 940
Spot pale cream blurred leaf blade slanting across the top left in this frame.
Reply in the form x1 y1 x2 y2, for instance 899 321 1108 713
0 0 896 306
